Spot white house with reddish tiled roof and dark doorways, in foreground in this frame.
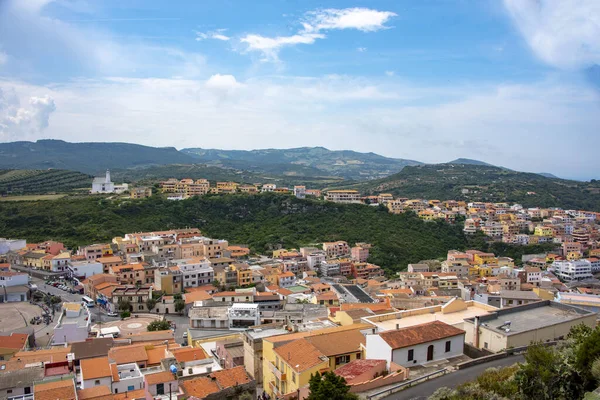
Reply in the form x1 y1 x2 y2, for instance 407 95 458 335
366 321 465 368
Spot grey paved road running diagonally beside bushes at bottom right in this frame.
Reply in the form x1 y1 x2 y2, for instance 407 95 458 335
384 355 524 400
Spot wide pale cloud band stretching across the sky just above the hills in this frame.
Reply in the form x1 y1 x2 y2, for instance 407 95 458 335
0 74 600 178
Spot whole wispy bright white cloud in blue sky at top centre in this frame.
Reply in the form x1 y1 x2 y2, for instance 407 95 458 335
240 8 396 61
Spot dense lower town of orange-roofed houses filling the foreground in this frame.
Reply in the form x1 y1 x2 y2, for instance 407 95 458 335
0 228 600 400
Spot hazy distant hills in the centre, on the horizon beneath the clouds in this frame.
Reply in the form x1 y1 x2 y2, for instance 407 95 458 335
181 147 421 180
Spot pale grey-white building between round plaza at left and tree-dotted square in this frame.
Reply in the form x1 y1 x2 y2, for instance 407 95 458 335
52 303 91 345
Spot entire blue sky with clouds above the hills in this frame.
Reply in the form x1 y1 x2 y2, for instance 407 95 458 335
0 0 600 179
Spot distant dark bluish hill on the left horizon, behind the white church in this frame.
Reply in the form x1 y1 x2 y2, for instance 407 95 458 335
0 140 197 174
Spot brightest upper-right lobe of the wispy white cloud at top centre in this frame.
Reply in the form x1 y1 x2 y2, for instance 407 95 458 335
303 7 397 32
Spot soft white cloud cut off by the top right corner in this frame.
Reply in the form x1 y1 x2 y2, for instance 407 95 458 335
504 0 600 69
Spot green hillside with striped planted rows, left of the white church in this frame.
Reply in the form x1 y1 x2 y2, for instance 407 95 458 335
0 169 92 195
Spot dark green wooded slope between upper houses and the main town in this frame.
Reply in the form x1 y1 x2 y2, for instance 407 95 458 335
0 194 466 271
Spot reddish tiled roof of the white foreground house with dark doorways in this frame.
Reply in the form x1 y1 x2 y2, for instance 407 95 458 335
379 321 465 349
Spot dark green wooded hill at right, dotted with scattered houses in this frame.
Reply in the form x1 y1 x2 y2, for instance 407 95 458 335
352 164 600 211
